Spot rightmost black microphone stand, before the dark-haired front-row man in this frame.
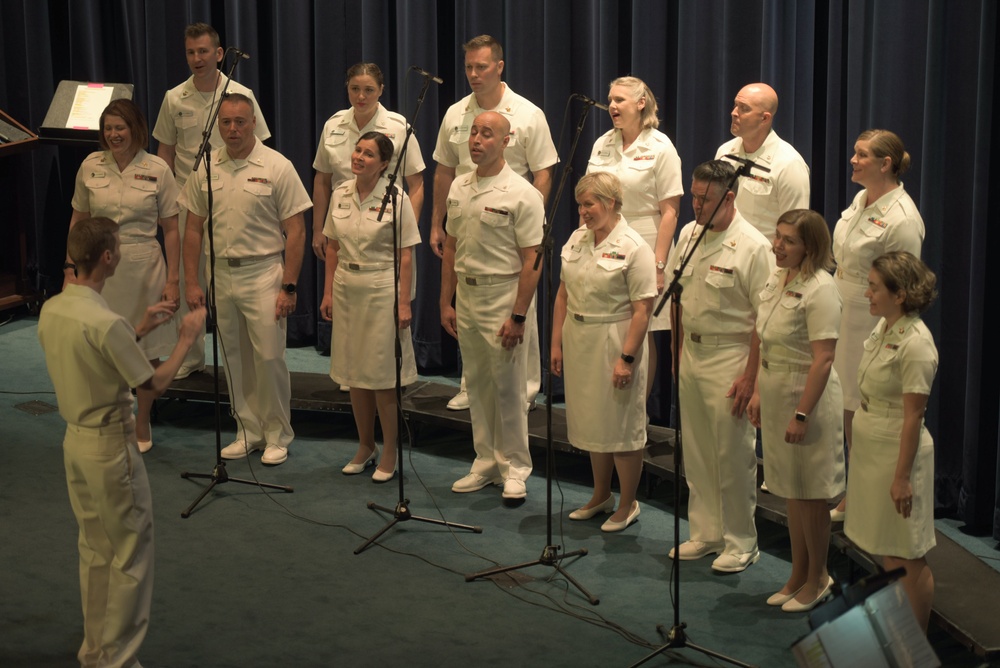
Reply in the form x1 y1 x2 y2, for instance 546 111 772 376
632 156 756 668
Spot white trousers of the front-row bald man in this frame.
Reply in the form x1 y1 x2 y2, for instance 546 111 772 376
455 276 537 480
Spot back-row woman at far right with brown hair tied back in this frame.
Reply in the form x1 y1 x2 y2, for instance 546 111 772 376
831 130 924 521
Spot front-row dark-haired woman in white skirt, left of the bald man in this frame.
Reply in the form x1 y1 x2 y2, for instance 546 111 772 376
320 132 420 482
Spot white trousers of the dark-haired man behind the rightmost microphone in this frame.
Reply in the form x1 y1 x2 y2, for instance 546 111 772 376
679 337 757 554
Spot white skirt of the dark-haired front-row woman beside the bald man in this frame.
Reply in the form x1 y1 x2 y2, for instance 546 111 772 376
330 263 417 390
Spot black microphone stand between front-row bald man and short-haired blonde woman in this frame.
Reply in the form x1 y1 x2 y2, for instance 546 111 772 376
465 94 601 605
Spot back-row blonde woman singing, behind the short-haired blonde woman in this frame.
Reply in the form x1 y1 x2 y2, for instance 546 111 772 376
587 77 684 397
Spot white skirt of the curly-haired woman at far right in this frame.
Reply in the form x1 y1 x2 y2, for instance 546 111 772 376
844 409 936 559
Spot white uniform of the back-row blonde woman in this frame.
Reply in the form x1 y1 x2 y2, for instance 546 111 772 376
587 128 684 332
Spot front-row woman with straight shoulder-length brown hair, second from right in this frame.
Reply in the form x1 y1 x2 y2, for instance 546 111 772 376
747 209 844 612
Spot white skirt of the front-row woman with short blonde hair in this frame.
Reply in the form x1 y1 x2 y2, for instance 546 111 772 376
563 315 648 452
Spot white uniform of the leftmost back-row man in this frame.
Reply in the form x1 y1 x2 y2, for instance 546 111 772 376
153 72 271 368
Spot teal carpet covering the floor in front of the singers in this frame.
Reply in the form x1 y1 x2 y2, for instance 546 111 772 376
0 318 992 668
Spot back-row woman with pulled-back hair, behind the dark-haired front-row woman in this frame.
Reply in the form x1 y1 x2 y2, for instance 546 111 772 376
312 62 424 260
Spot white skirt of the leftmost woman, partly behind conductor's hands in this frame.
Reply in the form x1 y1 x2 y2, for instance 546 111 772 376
101 239 175 360
